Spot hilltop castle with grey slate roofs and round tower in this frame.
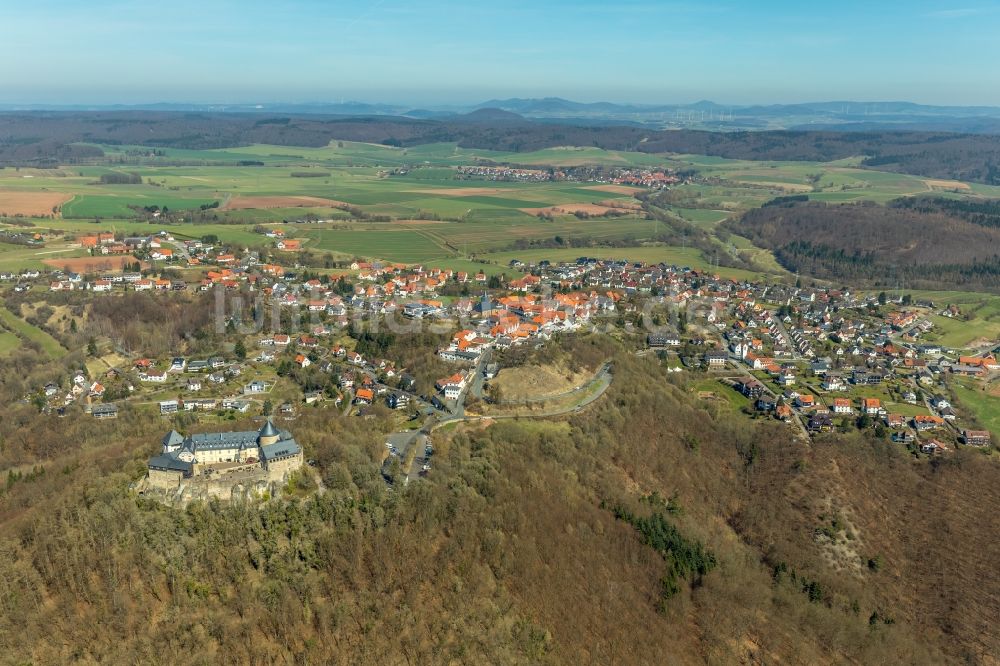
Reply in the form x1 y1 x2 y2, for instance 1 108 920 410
147 419 303 490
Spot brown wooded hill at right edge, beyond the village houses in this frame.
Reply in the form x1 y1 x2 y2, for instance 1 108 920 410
726 197 1000 291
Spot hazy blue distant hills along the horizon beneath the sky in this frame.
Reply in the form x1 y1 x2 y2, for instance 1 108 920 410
0 97 1000 134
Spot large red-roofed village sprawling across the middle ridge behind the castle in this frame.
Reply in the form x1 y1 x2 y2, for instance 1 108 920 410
0 227 1000 486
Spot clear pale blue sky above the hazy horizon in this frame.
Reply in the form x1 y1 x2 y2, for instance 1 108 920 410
0 0 1000 106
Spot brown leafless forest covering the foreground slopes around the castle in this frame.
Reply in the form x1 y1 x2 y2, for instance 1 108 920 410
0 338 1000 664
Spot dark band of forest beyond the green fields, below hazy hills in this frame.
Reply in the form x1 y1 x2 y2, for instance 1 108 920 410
0 111 1000 184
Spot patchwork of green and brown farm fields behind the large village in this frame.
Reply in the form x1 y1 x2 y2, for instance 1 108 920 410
0 142 1000 282
